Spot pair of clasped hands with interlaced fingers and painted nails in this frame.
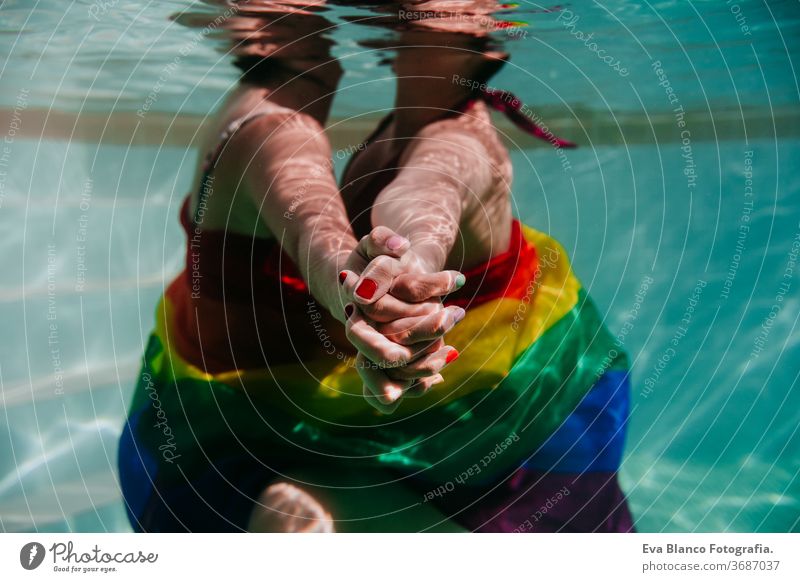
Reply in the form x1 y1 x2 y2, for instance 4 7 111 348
339 226 465 414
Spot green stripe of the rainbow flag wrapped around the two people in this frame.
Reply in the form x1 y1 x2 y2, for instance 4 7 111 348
126 291 627 483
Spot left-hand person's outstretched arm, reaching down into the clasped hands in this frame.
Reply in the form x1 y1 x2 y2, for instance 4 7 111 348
240 107 458 336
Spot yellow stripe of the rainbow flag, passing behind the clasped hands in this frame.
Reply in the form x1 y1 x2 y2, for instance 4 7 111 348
150 226 580 423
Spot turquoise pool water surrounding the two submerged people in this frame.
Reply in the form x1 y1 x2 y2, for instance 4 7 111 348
0 1 800 531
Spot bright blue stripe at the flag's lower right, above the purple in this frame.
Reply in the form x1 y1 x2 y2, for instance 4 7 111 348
523 370 630 473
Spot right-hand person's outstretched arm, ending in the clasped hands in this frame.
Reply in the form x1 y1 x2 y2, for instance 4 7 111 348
338 120 494 413
